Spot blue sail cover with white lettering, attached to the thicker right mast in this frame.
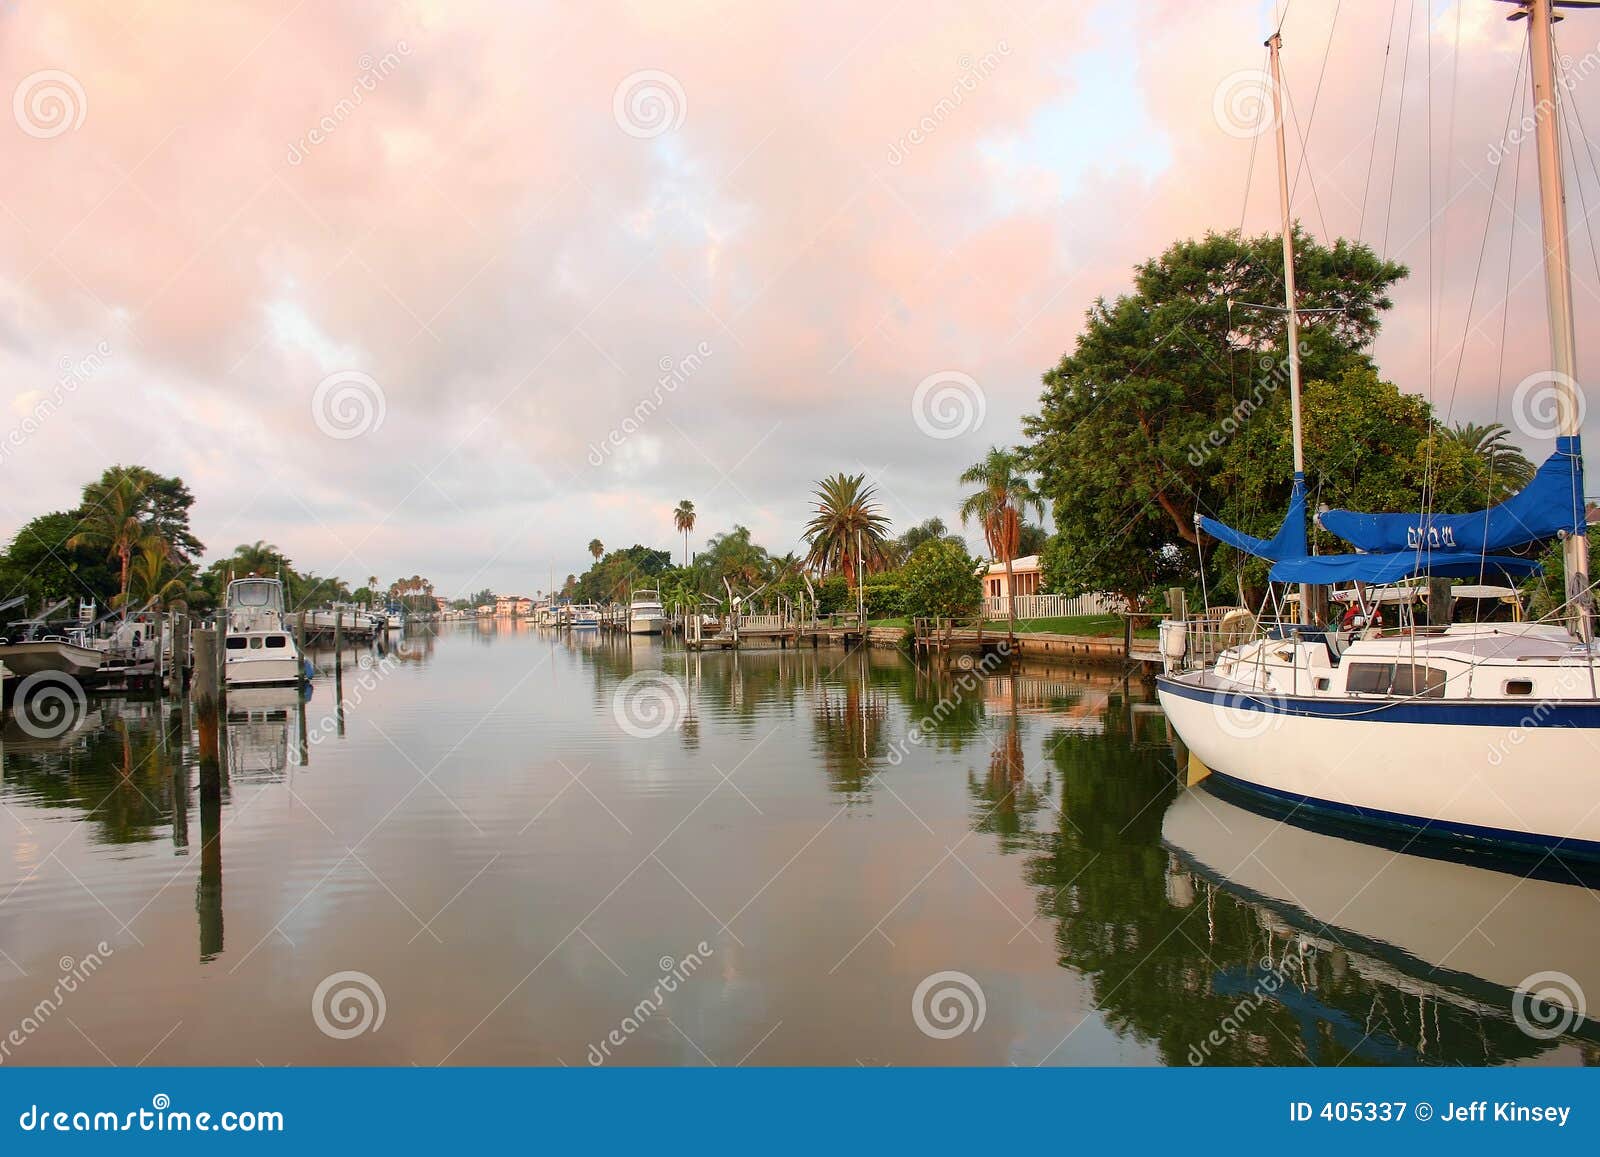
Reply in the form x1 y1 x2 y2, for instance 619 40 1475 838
1312 437 1584 556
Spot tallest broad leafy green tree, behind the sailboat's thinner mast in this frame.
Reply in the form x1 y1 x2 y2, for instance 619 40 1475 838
1024 229 1406 602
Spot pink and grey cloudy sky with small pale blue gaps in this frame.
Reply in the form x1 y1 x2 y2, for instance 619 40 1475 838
0 0 1600 595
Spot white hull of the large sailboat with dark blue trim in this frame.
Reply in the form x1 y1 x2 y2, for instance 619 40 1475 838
1157 675 1600 856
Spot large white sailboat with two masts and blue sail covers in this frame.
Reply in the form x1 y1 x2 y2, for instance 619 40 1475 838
1157 0 1600 858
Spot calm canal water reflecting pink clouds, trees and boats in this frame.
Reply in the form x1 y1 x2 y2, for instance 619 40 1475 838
0 624 1600 1066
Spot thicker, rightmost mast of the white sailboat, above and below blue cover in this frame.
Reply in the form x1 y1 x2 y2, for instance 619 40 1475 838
1525 0 1592 643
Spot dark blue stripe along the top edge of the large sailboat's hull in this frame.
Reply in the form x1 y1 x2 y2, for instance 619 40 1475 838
1155 675 1600 731
